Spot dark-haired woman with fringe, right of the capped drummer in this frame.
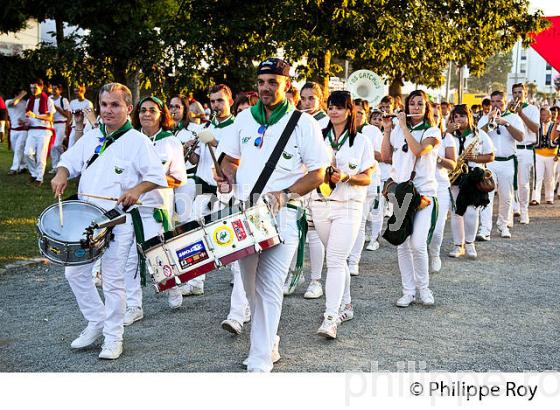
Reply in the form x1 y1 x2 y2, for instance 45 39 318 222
310 91 377 339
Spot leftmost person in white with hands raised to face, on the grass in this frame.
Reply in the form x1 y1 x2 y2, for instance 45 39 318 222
6 90 27 175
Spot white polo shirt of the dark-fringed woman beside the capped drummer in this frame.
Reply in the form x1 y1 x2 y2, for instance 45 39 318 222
311 133 377 202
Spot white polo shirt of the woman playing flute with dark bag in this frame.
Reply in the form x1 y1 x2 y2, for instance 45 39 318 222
390 124 441 196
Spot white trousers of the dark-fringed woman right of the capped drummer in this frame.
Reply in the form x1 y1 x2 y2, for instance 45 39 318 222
310 201 364 317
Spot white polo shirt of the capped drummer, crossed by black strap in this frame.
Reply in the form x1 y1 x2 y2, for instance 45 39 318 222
219 109 330 201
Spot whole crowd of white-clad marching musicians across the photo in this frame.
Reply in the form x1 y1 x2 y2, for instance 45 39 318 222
0 58 560 372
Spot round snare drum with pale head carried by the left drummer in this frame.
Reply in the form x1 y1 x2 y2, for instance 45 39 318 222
36 201 111 266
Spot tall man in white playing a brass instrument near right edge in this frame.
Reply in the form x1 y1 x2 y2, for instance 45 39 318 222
511 83 540 224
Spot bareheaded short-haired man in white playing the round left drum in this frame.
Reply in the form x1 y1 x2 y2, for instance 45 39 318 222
51 83 167 359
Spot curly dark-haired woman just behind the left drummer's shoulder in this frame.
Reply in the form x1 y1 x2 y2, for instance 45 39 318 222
124 96 187 320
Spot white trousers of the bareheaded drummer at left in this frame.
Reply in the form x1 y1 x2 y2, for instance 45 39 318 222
64 218 134 342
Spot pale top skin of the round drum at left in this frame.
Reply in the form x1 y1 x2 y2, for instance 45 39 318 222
39 201 105 242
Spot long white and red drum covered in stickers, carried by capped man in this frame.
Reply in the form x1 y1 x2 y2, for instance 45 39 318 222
140 204 281 292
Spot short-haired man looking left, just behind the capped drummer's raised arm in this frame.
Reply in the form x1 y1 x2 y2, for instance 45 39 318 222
185 84 235 296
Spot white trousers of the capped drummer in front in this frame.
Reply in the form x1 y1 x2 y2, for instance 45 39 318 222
239 207 298 372
